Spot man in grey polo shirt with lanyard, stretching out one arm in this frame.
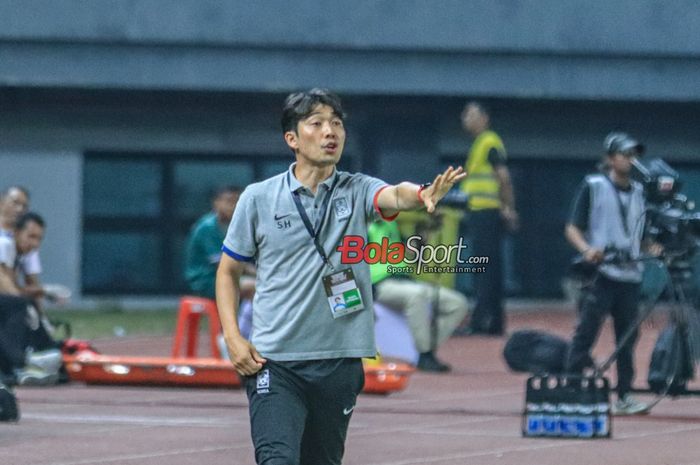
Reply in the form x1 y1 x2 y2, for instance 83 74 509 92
216 89 465 465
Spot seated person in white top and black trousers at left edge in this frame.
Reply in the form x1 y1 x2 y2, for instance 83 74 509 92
0 213 61 384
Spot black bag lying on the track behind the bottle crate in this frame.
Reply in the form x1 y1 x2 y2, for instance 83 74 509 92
503 329 569 374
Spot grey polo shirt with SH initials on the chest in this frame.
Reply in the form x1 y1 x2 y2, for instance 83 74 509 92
223 164 386 361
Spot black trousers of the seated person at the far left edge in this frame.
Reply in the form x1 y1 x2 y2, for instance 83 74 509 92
0 294 29 374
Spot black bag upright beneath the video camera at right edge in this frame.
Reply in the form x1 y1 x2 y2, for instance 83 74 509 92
647 323 693 396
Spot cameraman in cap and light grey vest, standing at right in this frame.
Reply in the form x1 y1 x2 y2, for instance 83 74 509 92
565 132 660 415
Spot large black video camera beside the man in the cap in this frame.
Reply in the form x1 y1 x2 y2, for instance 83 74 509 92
633 158 700 259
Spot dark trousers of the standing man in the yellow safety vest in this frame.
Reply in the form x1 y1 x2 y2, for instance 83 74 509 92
469 209 505 334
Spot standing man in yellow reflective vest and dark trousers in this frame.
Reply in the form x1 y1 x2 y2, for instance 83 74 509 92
458 102 518 336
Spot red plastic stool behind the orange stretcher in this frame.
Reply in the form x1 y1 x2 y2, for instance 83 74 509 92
173 295 221 358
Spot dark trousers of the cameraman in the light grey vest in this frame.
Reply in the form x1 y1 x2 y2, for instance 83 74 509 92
566 275 640 397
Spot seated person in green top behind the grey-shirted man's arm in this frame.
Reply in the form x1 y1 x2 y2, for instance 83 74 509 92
185 186 255 338
